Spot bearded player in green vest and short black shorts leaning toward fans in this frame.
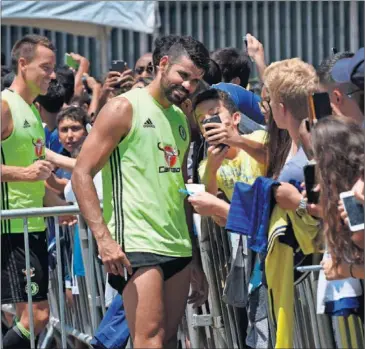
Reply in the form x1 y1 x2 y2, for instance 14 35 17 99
72 37 209 348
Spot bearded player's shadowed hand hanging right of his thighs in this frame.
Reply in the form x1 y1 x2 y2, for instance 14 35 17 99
188 262 209 308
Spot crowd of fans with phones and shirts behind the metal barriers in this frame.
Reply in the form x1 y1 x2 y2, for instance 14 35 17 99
2 34 364 347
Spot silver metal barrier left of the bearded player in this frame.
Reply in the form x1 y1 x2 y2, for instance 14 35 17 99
0 205 106 349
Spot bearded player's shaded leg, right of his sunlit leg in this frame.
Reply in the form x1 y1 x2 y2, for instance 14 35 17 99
164 265 191 349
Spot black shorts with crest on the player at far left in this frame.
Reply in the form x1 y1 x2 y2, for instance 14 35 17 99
1 232 48 303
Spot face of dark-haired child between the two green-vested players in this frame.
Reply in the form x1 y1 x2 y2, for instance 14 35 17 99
58 118 87 153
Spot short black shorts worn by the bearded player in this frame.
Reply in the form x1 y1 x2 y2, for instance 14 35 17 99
108 252 192 294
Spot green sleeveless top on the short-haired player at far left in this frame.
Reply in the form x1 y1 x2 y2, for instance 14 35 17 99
1 90 45 234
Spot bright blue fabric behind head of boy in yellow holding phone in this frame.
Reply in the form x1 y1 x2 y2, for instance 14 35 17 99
212 82 265 125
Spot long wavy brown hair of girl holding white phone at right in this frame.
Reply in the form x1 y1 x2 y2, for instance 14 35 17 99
312 116 365 264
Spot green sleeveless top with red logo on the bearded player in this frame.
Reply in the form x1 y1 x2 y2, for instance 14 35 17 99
102 89 192 257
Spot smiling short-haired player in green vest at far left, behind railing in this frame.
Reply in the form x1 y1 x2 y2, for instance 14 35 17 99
1 35 75 349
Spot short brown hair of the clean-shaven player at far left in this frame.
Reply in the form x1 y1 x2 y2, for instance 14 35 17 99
11 34 55 74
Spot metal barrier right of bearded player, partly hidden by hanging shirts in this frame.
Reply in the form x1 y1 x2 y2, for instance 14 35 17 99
183 217 364 349
